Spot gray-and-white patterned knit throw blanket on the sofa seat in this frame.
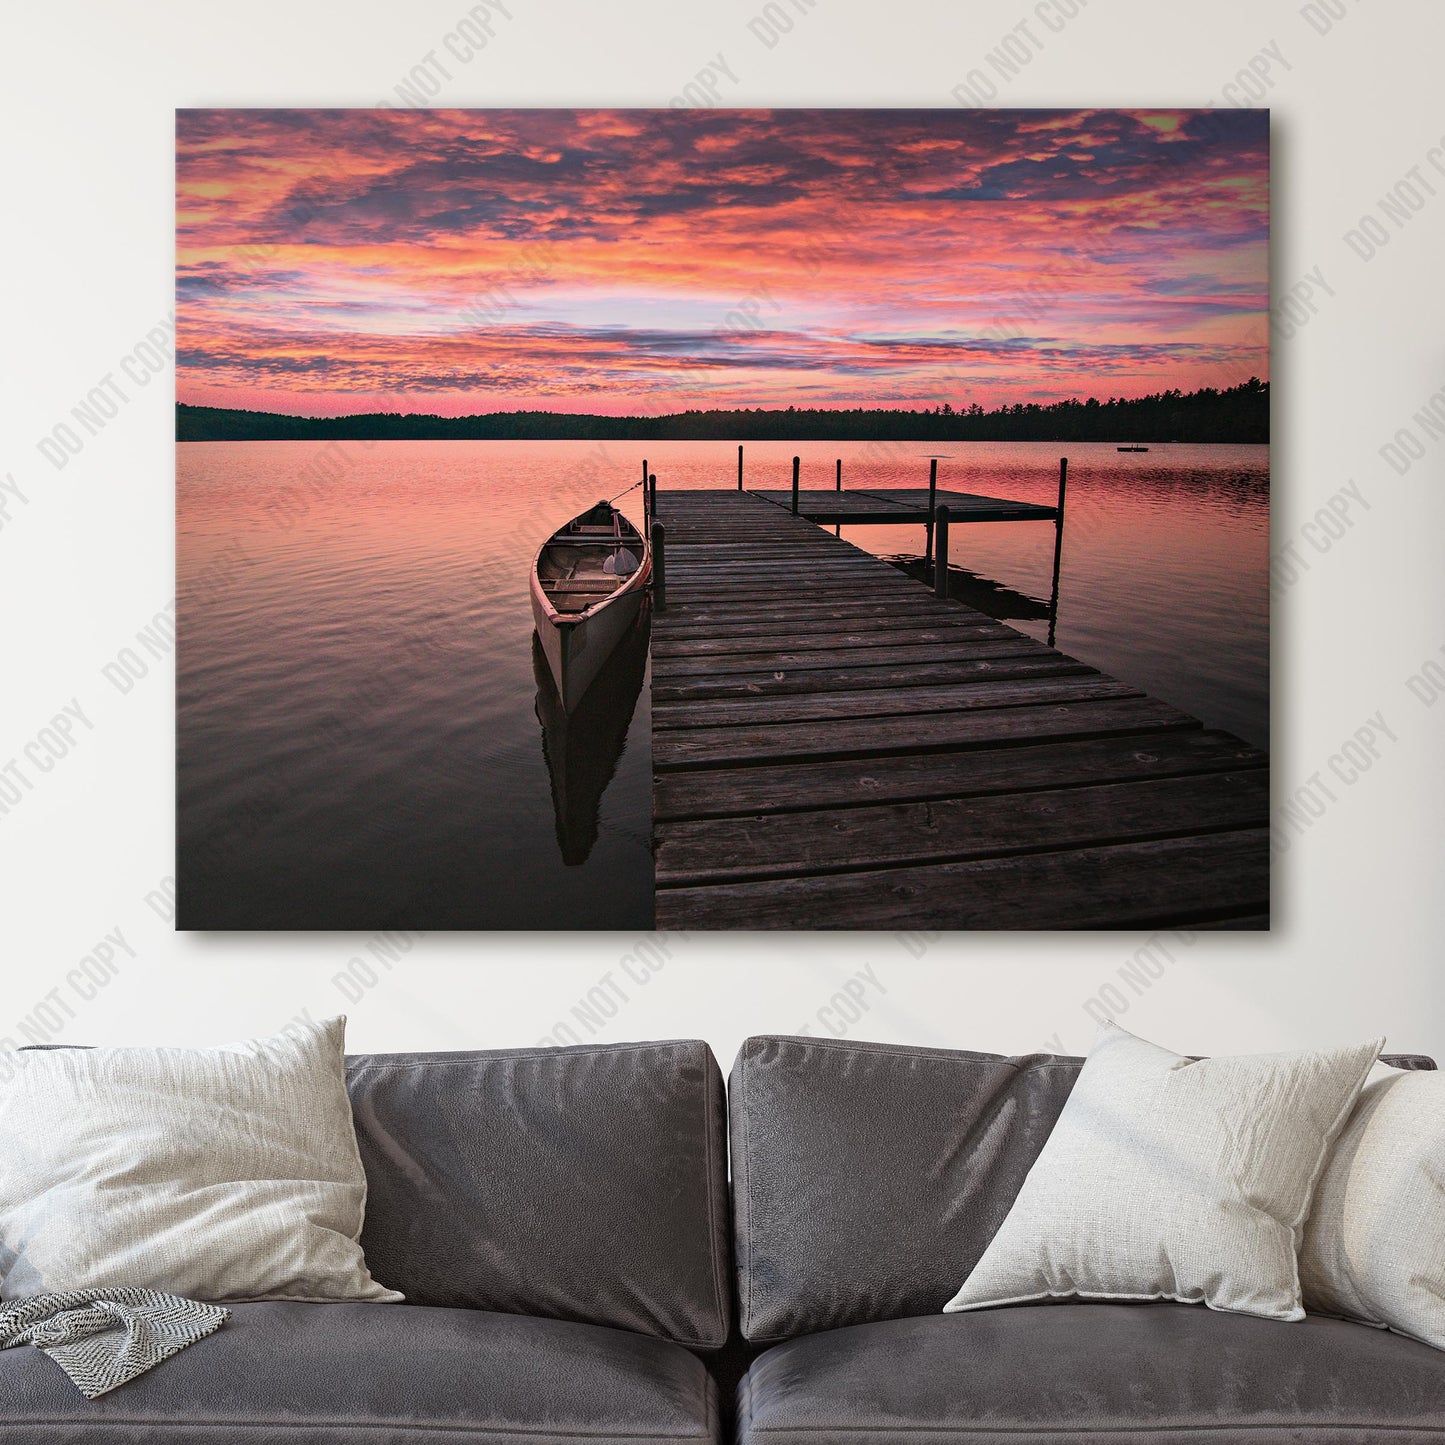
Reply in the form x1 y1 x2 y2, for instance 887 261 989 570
0 1289 231 1400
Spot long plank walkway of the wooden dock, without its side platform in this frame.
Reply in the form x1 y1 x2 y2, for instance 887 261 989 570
652 490 1269 929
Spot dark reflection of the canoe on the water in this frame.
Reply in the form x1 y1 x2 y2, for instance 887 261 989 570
532 604 652 868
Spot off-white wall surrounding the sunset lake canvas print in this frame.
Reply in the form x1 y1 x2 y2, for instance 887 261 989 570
0 0 1445 1064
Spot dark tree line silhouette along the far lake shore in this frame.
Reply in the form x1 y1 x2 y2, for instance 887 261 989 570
176 376 1269 442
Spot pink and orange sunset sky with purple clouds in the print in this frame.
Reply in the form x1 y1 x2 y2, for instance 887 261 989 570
176 108 1269 416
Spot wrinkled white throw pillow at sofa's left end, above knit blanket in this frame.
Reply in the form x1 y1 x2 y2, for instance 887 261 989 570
0 1019 402 1301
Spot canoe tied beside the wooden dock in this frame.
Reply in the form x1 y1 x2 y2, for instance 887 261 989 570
532 501 652 712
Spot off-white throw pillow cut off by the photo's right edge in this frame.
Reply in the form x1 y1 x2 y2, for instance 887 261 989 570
1299 1065 1445 1350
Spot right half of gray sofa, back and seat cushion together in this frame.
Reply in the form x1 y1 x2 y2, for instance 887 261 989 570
728 1038 1445 1445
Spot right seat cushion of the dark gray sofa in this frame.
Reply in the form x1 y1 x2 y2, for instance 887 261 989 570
738 1303 1445 1445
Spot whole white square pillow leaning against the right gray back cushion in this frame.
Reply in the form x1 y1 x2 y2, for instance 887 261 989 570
944 1023 1384 1319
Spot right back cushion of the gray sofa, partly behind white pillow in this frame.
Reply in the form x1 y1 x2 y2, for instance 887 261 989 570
734 1036 1433 1344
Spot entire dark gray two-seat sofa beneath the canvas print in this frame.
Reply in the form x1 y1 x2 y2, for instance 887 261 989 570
0 1038 1445 1445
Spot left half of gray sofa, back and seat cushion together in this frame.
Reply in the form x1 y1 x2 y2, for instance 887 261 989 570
0 1043 731 1445
